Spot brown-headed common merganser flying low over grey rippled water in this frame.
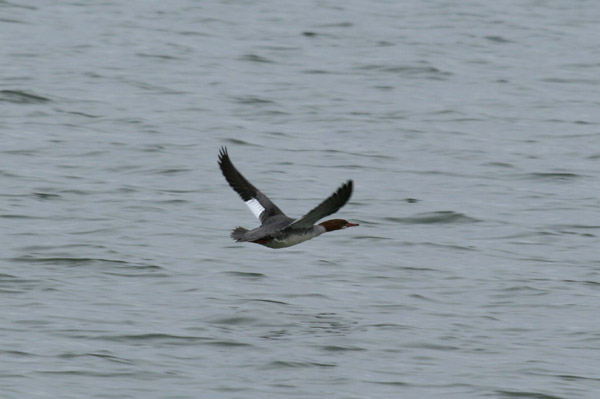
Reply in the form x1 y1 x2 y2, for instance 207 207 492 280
219 147 358 248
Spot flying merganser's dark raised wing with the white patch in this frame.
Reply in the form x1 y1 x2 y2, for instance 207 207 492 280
219 147 283 223
